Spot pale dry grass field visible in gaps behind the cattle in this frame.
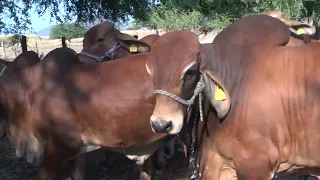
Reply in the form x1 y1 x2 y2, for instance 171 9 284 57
0 30 219 60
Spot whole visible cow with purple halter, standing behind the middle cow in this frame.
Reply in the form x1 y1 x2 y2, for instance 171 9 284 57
79 21 174 176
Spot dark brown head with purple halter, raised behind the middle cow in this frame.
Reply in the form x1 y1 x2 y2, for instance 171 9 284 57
79 21 150 63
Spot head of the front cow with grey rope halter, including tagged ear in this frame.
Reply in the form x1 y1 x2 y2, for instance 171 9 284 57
146 31 230 134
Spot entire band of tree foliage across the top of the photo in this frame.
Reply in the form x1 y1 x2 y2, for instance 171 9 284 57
0 0 320 33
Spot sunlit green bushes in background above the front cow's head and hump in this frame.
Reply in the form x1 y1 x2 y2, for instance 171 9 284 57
144 0 304 31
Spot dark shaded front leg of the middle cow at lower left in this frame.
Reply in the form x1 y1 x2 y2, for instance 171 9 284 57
37 141 76 180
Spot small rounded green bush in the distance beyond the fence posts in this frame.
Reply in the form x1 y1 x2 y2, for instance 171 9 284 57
50 24 87 39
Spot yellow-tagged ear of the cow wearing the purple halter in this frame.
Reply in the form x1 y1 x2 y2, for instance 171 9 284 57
116 31 150 53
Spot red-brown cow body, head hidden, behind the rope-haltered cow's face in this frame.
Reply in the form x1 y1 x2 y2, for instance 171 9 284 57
0 43 190 180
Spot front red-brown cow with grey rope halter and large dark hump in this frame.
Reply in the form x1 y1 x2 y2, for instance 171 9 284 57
146 15 320 180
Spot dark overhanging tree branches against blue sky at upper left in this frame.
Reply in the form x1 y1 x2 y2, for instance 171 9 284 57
0 0 152 34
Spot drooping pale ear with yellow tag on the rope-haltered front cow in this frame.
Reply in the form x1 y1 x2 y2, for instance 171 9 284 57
202 69 231 118
